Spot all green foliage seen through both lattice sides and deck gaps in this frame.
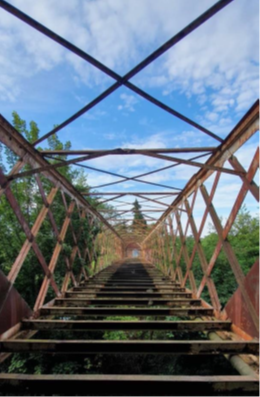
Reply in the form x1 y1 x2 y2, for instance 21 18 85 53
0 112 260 375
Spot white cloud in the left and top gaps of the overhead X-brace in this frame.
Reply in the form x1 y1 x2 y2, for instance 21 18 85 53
0 0 220 101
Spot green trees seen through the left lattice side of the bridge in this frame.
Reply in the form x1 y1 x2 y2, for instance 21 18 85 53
0 112 100 307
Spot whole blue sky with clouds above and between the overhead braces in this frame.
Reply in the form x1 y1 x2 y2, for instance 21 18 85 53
0 0 260 230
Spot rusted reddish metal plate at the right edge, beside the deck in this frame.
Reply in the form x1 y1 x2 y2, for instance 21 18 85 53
225 260 260 338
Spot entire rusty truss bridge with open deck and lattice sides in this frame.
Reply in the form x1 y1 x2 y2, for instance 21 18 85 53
0 0 260 397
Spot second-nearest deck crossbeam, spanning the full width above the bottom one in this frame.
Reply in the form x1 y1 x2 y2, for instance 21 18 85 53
0 339 260 355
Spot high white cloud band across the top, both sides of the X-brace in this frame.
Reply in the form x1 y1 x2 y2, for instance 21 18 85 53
0 0 260 123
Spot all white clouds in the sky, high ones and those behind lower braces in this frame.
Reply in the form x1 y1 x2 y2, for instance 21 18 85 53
0 0 260 229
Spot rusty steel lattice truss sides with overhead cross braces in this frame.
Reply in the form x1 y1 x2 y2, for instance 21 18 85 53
0 0 260 392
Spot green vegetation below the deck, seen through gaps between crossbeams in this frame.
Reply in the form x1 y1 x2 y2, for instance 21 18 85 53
3 316 236 375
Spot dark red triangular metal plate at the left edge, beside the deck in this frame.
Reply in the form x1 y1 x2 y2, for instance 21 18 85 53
0 271 32 335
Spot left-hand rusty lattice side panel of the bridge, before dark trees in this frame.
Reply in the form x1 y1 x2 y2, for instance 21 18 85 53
0 135 122 332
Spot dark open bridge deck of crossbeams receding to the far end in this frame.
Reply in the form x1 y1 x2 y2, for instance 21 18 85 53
0 262 260 396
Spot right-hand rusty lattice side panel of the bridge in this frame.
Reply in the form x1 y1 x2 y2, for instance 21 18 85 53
145 106 260 332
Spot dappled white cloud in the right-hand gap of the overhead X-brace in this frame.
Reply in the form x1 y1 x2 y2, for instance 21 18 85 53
137 0 260 121
